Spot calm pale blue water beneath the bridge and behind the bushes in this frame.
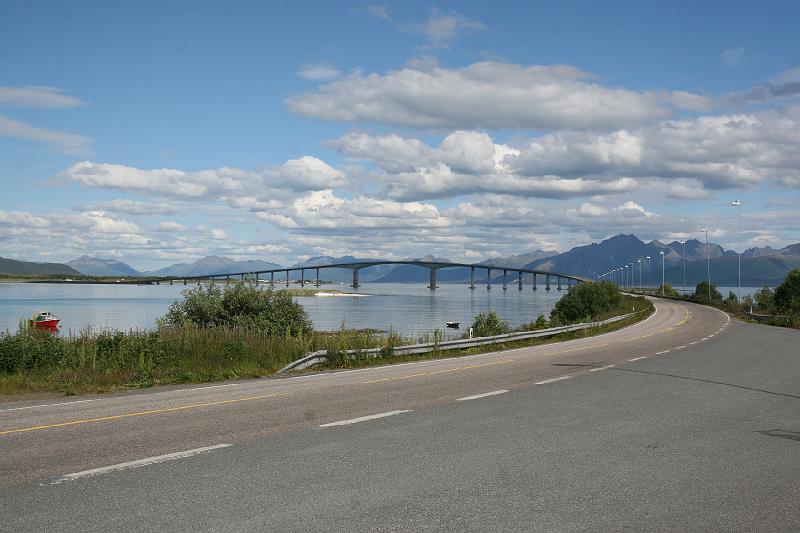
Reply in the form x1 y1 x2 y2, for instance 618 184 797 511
0 283 562 336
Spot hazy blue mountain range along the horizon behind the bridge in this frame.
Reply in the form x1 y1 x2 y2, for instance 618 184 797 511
0 235 800 286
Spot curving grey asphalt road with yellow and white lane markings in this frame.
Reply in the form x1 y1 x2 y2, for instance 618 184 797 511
0 301 800 531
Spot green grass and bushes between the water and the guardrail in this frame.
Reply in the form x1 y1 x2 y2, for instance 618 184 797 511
0 281 651 395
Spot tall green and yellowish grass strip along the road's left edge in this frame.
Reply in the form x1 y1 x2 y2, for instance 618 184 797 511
0 297 652 396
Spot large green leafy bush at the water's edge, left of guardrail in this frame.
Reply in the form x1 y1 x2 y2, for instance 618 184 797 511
162 281 312 336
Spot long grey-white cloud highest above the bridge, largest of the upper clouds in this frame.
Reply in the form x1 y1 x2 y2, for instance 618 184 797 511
284 61 672 130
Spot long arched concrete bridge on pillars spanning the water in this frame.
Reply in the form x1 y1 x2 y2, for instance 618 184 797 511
151 261 591 291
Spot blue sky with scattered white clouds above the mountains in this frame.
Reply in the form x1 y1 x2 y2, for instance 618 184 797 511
0 0 800 270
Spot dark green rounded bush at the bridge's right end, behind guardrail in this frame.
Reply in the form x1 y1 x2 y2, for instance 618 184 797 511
550 281 622 324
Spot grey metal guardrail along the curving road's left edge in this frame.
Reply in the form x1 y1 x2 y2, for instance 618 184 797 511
277 309 644 374
